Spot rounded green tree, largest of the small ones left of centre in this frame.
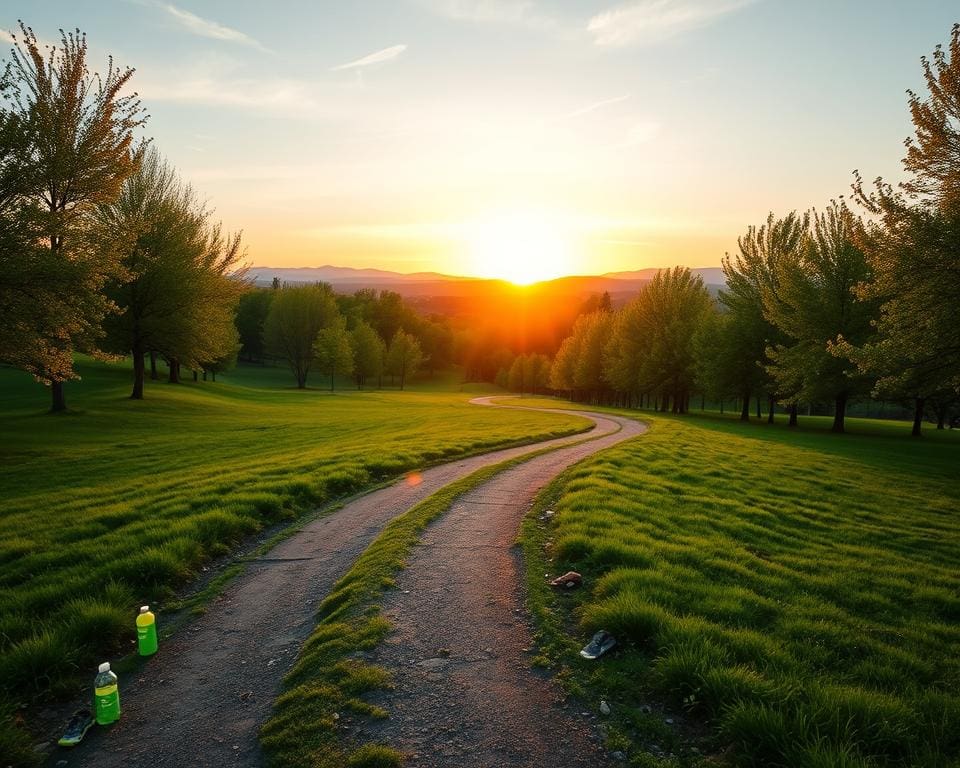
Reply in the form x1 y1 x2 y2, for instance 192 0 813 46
264 283 337 389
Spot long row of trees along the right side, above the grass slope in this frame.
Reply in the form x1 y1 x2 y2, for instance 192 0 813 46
550 25 960 435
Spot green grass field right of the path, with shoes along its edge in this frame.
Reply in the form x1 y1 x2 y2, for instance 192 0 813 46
523 401 960 768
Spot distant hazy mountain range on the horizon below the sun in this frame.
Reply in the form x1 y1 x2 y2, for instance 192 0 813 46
247 265 725 303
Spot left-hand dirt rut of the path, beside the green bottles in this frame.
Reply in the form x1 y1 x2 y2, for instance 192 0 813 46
49 399 637 768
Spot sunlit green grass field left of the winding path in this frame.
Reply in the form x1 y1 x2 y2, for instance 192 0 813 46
0 361 585 751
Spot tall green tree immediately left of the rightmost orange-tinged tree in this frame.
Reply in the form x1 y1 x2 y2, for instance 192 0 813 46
764 202 876 432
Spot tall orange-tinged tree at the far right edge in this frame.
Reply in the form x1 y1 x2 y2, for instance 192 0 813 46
848 24 960 436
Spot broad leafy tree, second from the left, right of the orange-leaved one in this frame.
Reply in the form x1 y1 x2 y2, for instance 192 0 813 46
95 150 246 400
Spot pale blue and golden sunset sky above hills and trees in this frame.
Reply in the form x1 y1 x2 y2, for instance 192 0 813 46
0 0 960 281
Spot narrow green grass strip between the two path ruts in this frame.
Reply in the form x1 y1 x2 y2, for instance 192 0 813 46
260 420 616 768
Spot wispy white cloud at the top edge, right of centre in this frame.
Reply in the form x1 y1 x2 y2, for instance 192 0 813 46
587 0 755 46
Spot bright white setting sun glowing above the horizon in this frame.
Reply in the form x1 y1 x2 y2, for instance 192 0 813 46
466 208 572 285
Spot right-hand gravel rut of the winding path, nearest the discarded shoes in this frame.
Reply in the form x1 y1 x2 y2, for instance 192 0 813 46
365 404 646 768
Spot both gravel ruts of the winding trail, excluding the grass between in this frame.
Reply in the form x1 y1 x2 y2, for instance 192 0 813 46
58 398 645 768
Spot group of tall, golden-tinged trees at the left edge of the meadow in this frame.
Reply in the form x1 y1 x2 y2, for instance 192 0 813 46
0 23 245 411
